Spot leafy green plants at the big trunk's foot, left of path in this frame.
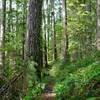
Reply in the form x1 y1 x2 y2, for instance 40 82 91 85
23 61 45 100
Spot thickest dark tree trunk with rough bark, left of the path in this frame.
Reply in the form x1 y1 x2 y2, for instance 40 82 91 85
28 0 43 78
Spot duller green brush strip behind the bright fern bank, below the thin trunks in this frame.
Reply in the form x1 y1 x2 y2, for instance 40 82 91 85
50 56 96 79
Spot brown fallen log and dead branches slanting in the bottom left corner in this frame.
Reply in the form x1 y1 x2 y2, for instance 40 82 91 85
0 72 24 100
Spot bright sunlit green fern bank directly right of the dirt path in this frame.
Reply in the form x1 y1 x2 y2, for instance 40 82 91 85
54 62 100 100
